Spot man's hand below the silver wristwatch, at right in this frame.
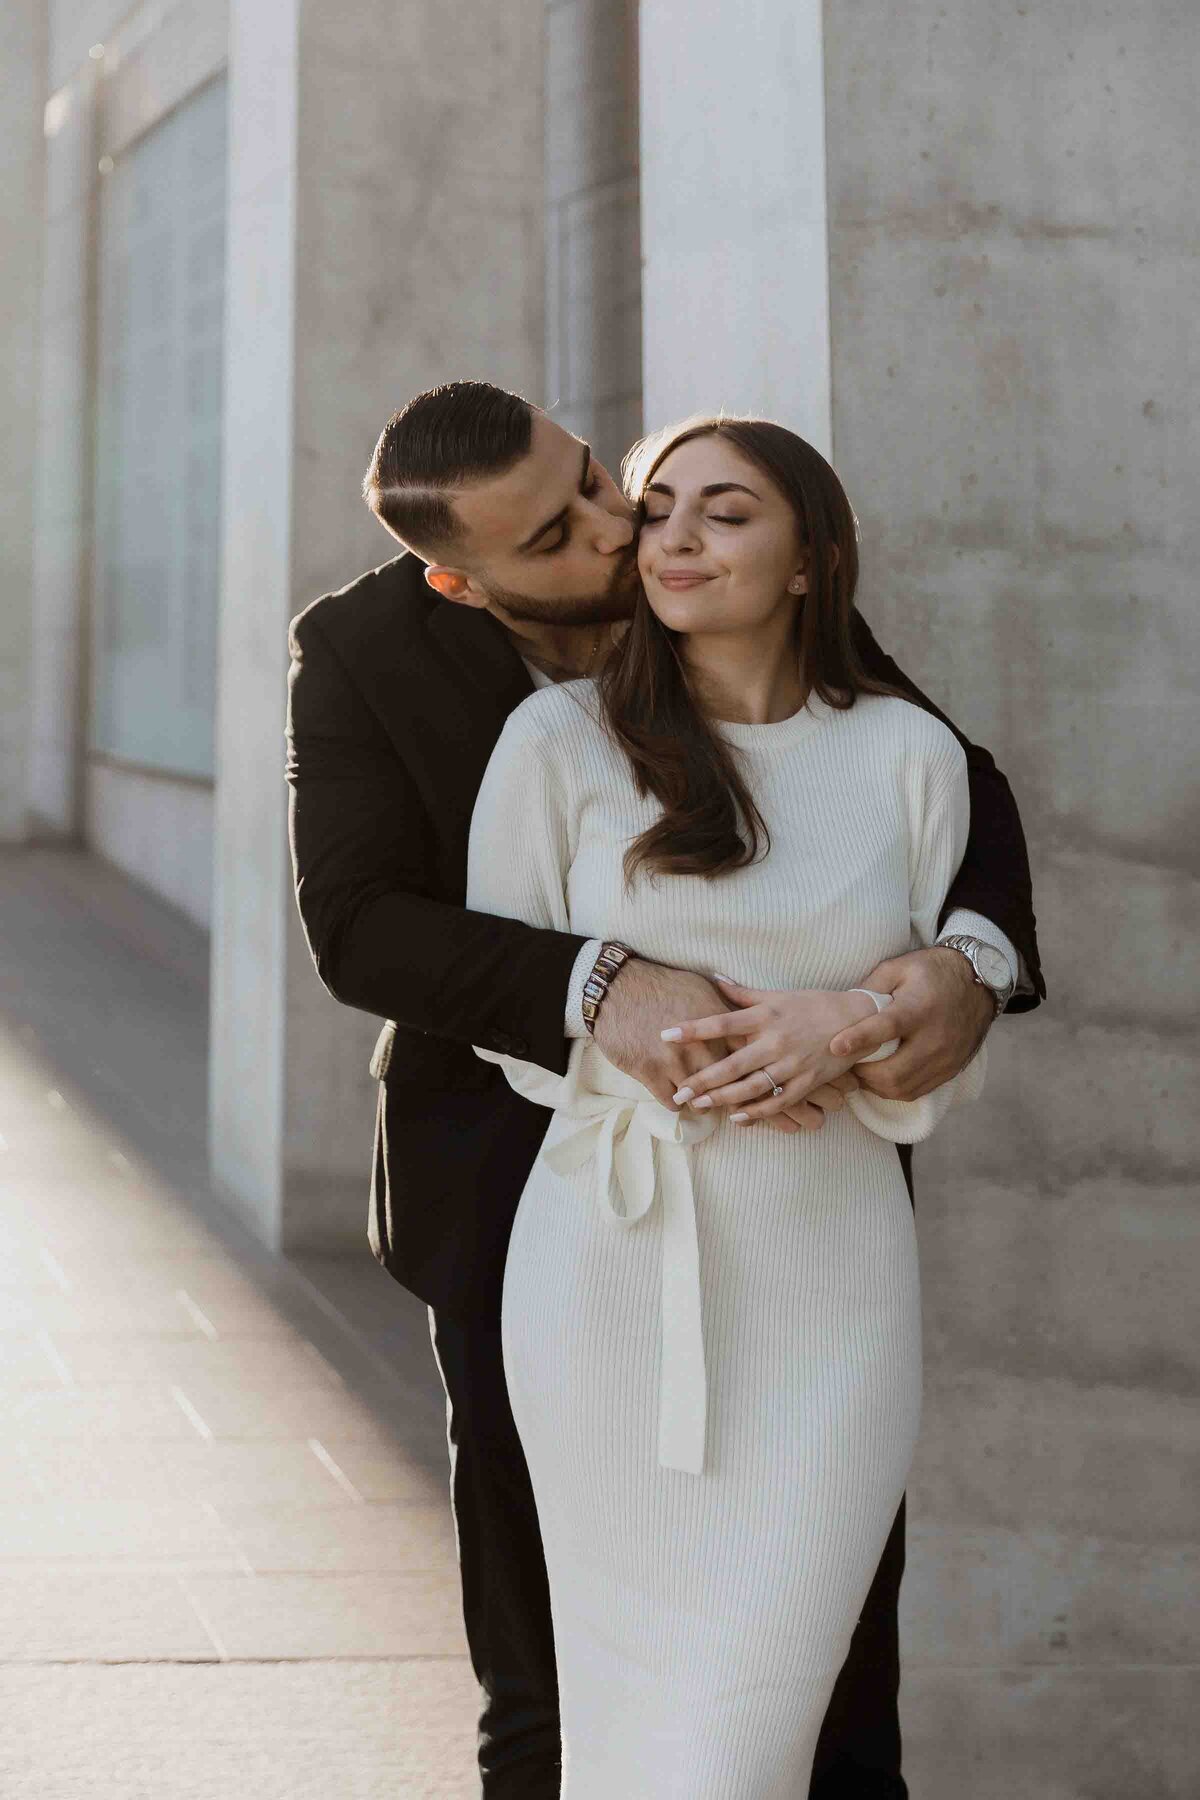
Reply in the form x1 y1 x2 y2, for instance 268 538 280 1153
829 947 995 1100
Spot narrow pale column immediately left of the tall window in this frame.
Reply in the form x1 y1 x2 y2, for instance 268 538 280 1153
29 56 97 839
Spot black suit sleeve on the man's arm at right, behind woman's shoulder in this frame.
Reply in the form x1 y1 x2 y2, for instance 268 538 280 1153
853 612 1045 1012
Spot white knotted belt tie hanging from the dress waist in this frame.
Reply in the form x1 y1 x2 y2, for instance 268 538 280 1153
542 1089 716 1474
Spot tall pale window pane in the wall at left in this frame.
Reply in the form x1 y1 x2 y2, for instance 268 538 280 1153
92 79 225 776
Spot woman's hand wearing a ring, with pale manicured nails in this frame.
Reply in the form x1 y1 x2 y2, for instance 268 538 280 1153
664 976 874 1130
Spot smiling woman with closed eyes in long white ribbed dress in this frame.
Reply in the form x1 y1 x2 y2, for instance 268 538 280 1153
468 419 982 1800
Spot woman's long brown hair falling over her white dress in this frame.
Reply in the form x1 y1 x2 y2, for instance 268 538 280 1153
599 414 894 882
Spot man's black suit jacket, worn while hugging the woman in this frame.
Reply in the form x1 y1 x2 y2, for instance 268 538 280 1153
288 556 1045 1321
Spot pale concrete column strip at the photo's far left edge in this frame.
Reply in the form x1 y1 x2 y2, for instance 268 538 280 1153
0 0 47 842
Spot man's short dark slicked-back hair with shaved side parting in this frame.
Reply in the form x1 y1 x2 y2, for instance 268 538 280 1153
362 382 533 560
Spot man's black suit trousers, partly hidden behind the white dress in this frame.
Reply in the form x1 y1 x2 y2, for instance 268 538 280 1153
430 1309 909 1800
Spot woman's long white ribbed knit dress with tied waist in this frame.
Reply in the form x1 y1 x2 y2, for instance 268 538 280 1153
468 682 984 1800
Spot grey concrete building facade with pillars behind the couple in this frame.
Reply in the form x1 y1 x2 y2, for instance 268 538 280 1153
0 0 1200 1800
